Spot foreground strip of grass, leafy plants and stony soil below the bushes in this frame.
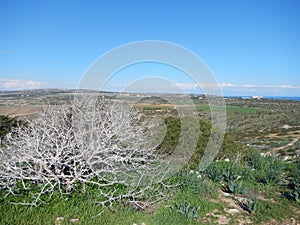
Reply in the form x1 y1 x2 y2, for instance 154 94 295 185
0 152 300 225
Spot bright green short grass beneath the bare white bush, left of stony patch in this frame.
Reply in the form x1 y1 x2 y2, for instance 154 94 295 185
0 182 220 225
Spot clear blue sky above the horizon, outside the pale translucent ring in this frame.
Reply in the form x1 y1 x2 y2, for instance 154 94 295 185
0 0 300 96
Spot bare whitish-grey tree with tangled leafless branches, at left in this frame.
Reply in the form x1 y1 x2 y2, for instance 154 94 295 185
0 97 168 208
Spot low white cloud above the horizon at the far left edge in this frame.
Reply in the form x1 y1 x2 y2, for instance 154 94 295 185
0 79 41 89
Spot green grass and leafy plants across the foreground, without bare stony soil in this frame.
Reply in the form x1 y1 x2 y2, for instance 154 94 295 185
0 132 300 225
